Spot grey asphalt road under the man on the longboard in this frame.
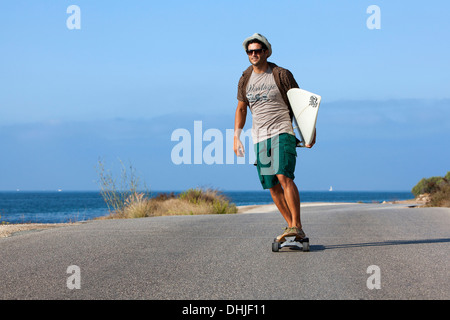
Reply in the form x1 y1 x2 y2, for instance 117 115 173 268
0 204 450 300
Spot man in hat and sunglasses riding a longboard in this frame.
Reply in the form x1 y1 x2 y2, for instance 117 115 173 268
233 33 315 240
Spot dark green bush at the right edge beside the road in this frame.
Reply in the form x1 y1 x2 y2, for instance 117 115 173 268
411 171 450 207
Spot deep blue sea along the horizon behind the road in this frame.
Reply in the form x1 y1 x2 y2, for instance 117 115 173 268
0 191 414 224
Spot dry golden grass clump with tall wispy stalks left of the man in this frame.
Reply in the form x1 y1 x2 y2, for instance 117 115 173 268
98 161 237 219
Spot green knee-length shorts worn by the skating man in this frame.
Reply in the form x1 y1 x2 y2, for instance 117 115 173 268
254 133 297 189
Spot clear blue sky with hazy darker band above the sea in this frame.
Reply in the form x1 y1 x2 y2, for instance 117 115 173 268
0 0 450 190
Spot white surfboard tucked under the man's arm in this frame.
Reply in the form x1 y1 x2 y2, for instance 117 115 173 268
287 88 322 147
